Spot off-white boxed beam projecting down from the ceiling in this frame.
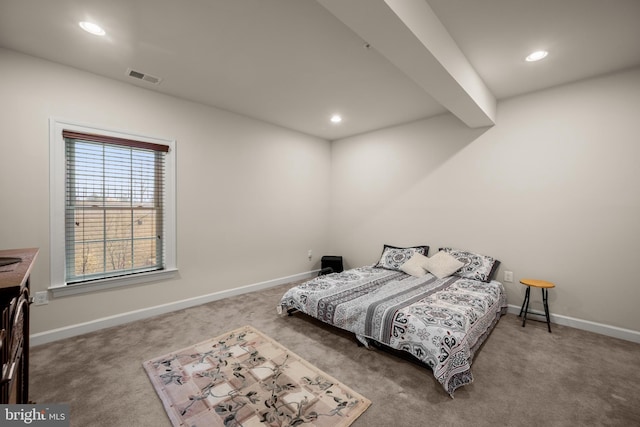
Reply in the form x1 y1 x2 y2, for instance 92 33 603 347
318 0 496 128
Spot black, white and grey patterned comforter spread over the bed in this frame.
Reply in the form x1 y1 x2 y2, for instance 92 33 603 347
278 266 507 397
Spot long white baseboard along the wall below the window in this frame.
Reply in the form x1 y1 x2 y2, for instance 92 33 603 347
29 270 319 346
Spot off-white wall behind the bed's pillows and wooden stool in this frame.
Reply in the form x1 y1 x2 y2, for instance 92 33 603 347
331 69 640 331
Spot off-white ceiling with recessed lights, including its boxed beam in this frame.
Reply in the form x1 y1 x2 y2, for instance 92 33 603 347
0 0 640 140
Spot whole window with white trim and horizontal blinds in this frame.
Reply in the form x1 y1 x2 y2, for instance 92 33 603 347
51 120 175 295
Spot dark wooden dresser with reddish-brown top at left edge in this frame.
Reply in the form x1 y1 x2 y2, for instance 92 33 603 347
0 248 38 404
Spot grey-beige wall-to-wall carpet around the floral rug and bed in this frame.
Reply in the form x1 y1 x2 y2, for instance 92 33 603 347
30 285 640 427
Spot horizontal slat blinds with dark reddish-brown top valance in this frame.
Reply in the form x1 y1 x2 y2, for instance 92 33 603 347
62 130 169 284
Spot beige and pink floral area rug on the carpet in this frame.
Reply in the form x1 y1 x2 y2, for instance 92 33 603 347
143 326 371 427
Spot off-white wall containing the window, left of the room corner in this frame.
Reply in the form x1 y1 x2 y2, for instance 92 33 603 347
0 49 330 333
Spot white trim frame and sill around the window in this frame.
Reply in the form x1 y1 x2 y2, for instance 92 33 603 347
49 118 178 297
